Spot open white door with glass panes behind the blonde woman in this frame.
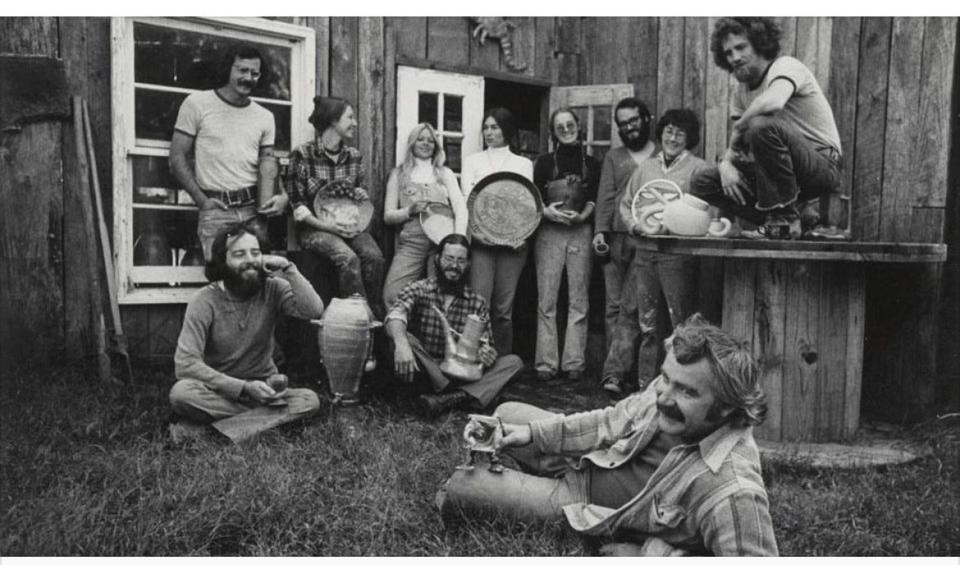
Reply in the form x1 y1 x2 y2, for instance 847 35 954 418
396 66 484 178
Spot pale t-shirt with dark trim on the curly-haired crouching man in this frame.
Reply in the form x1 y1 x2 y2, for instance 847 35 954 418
730 56 840 153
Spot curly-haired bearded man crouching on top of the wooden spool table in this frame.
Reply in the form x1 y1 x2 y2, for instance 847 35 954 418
692 18 842 239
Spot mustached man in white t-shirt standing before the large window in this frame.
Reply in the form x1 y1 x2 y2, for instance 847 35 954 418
170 46 287 261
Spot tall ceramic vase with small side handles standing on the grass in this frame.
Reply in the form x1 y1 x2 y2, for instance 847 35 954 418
312 294 383 406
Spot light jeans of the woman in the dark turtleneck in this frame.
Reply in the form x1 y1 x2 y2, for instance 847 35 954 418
534 222 593 374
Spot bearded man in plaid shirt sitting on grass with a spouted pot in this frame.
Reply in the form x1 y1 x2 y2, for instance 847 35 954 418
385 233 523 416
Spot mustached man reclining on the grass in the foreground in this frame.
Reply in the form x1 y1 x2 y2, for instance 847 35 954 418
437 314 777 555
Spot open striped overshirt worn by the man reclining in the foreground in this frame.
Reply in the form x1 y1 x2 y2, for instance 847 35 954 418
530 381 778 555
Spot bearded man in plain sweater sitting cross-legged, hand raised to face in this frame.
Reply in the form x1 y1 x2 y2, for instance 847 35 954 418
170 226 323 442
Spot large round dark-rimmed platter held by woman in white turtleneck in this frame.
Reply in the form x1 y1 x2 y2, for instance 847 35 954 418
467 172 543 247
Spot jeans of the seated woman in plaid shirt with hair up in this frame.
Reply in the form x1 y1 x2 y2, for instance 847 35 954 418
297 226 384 315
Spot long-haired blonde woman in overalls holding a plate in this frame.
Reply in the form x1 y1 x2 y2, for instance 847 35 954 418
383 123 467 310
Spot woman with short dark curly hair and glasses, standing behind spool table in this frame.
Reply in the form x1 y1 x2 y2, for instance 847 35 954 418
603 108 707 395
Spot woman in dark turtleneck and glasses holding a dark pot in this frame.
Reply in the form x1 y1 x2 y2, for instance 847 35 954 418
533 108 600 381
